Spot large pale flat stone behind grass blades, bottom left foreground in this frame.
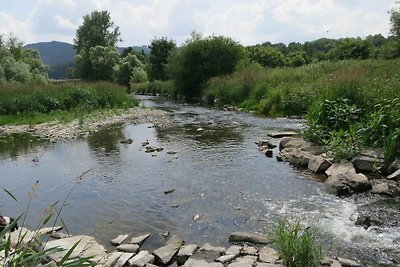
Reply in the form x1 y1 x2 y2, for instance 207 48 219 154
43 235 107 262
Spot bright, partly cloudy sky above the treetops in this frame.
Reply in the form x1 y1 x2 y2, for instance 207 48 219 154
0 0 396 46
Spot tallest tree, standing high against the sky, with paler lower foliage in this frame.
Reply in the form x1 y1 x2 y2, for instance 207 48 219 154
74 11 121 80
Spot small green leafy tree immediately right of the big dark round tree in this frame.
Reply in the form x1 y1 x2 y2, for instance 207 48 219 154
247 47 285 68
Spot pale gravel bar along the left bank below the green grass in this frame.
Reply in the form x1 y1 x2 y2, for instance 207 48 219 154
0 107 172 142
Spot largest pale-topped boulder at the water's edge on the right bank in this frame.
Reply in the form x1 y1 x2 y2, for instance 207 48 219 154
325 163 371 195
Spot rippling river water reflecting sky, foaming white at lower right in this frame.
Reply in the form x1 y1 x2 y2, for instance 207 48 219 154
0 97 400 266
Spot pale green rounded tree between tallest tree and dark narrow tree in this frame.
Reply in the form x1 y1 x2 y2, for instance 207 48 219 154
114 52 147 86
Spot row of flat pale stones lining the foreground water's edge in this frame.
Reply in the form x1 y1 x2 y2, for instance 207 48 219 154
5 227 361 267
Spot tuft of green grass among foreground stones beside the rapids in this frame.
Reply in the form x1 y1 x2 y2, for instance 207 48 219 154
274 222 322 267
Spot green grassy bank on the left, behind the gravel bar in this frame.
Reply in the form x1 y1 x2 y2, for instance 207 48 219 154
0 82 138 125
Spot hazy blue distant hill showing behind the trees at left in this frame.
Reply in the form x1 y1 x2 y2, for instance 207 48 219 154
24 41 150 79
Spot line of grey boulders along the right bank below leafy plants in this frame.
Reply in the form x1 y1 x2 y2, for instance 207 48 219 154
256 132 400 196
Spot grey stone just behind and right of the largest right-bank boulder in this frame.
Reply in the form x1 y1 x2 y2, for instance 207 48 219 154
353 149 385 172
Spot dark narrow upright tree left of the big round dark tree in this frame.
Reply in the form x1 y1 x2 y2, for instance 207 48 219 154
149 37 176 81
